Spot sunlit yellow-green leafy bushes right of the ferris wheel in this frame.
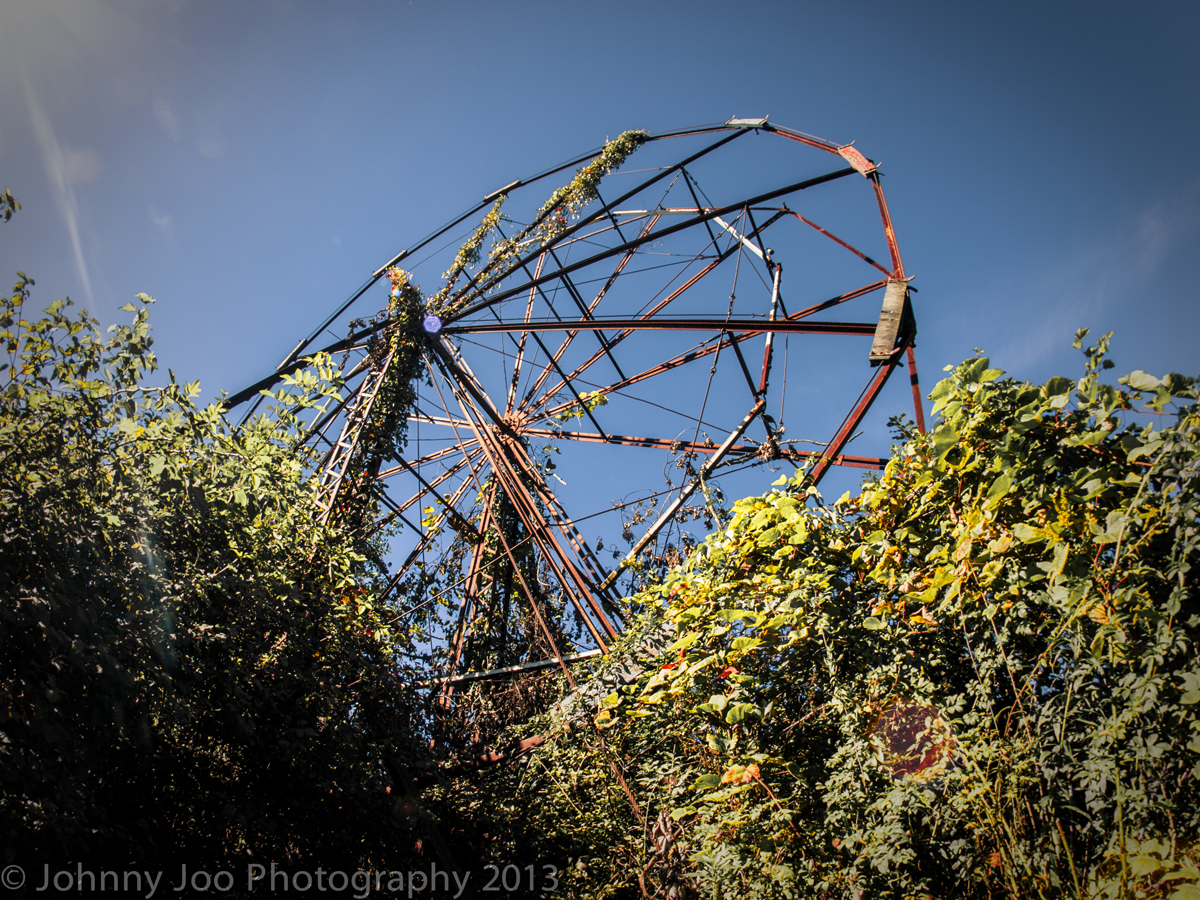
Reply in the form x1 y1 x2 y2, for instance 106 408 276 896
453 332 1200 900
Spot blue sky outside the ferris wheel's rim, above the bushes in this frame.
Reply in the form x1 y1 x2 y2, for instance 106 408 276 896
0 0 1200 520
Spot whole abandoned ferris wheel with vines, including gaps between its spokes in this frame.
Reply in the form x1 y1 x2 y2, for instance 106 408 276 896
228 119 924 720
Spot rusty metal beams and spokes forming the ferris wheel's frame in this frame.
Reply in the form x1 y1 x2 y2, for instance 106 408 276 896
227 120 925 697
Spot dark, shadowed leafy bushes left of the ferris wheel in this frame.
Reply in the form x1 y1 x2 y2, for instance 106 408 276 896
0 275 424 865
